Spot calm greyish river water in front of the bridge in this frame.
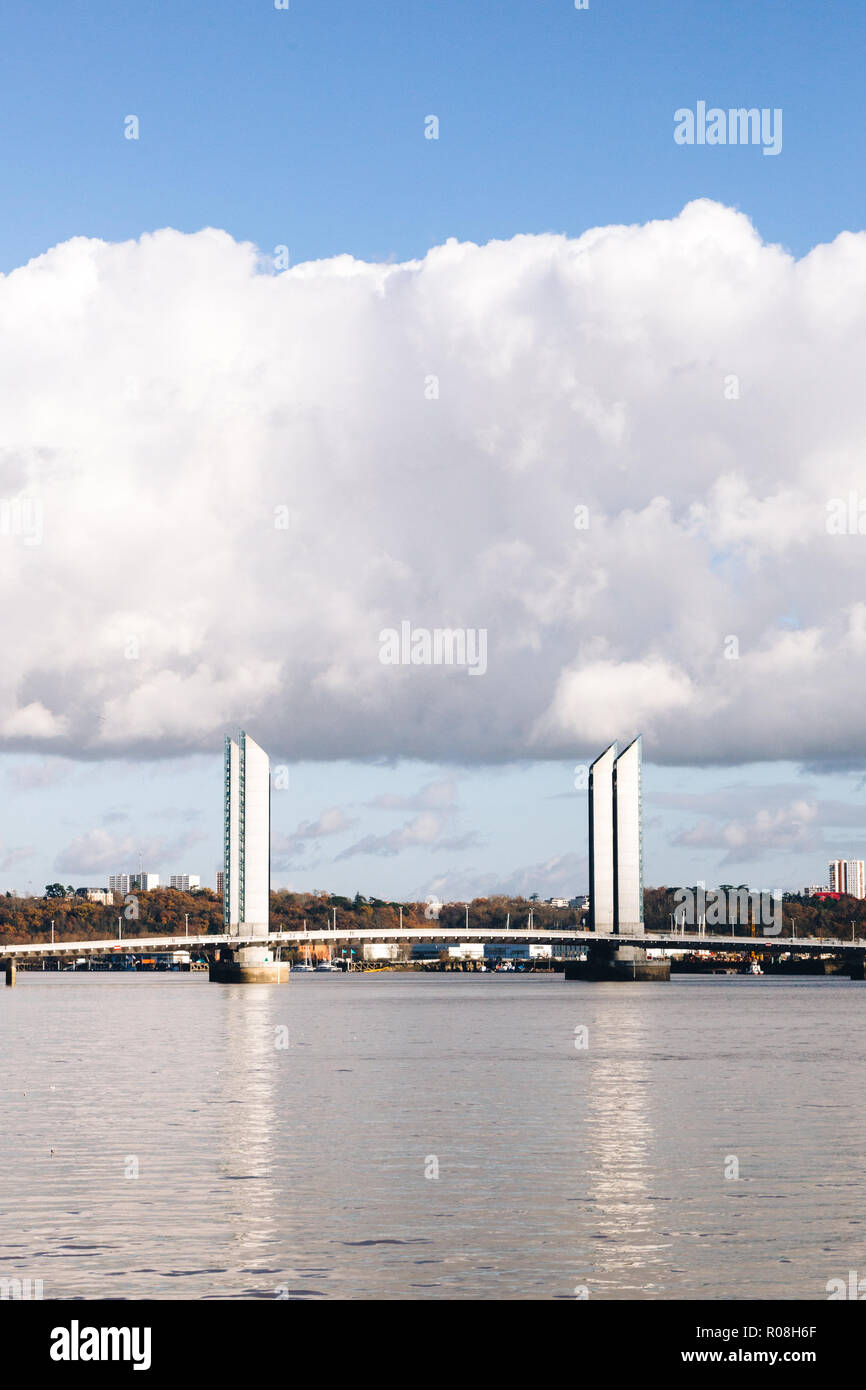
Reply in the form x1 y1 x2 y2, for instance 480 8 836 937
0 973 866 1300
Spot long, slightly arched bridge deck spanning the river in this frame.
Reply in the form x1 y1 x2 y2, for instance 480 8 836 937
0 927 866 960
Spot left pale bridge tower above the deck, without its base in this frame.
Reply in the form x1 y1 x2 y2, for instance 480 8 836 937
222 733 271 937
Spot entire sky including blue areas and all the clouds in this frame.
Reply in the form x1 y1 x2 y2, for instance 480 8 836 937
0 0 866 901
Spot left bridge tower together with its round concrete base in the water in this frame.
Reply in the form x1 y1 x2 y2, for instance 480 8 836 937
210 731 289 984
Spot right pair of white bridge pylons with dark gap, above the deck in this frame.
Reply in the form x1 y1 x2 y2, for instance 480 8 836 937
589 735 644 935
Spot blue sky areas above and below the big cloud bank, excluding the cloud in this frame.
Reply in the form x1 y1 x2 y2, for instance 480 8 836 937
0 0 866 897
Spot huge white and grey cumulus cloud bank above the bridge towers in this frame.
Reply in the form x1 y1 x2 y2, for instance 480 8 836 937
0 202 866 763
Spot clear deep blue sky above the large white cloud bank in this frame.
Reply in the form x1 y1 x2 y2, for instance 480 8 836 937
0 0 866 270
